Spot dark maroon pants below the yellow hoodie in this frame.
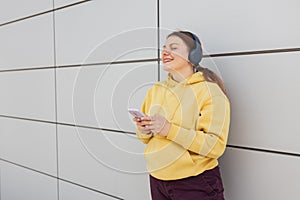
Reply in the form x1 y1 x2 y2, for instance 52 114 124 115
150 166 224 200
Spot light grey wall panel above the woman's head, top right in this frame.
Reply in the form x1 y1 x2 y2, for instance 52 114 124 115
160 0 300 54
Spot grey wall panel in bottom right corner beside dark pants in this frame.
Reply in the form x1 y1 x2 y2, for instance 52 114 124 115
220 148 300 200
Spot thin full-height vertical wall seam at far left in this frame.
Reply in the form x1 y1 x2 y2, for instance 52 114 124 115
52 0 59 200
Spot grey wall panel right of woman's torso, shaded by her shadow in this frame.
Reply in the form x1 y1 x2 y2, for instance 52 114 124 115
202 52 300 153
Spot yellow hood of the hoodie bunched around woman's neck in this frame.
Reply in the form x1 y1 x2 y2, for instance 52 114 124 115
162 72 205 87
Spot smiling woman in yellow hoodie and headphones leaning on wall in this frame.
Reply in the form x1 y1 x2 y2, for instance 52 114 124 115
134 31 230 200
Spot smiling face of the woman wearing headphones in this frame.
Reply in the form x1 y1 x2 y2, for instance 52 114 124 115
161 35 190 72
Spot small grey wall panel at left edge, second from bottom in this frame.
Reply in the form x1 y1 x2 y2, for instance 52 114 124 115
0 117 56 175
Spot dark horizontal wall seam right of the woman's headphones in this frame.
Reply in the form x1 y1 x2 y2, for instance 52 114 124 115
203 48 300 57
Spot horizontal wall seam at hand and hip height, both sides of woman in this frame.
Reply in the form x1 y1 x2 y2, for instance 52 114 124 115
0 115 300 157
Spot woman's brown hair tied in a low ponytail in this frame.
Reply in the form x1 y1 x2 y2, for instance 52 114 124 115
167 31 227 95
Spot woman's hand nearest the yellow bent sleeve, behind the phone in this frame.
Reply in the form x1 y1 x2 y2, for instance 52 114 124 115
145 114 171 136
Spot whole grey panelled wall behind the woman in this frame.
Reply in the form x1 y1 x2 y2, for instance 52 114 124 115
0 0 300 200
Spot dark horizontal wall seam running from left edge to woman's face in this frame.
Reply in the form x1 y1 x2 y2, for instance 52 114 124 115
0 58 159 72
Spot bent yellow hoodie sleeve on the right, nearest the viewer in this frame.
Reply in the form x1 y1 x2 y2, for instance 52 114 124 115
167 94 230 158
